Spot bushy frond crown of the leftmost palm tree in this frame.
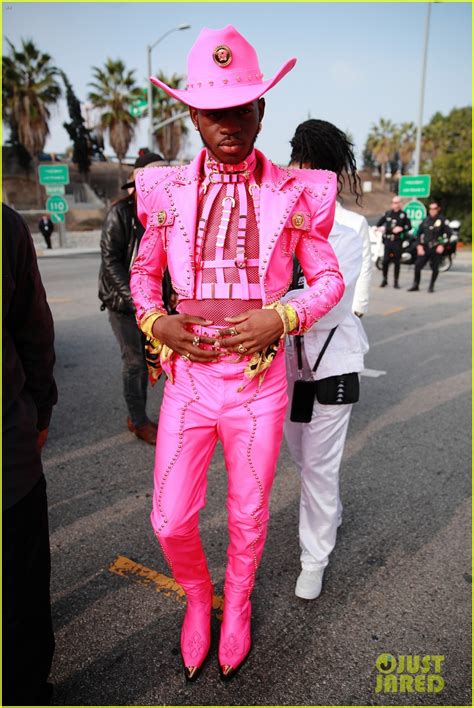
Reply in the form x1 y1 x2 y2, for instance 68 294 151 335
2 39 61 157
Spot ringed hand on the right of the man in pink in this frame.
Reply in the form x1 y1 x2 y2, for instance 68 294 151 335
219 310 284 354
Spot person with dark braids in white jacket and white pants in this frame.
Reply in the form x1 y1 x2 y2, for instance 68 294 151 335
284 120 372 600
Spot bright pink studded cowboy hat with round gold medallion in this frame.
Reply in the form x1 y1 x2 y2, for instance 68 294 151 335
150 25 296 109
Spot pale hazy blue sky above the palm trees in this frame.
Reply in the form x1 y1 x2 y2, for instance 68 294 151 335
2 2 471 164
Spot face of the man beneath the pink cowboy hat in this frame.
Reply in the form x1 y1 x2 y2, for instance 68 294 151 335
189 98 265 165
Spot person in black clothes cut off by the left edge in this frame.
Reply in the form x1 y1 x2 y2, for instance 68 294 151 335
2 205 57 706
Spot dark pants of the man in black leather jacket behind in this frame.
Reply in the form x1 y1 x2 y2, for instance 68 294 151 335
109 310 148 428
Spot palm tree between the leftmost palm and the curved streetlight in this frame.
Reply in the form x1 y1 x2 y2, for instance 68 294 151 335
88 59 141 183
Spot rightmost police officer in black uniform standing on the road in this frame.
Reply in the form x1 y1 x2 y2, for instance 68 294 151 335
408 201 452 293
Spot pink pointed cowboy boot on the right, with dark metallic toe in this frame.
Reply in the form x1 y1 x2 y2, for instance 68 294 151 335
219 590 252 681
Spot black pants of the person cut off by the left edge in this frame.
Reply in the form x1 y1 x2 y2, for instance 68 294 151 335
2 477 54 706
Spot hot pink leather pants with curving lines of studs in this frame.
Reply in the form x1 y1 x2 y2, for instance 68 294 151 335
151 351 287 597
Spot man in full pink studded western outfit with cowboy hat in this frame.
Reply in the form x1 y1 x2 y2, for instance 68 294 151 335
130 25 344 680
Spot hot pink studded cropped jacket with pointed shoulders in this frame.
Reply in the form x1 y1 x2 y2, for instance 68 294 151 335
130 150 344 334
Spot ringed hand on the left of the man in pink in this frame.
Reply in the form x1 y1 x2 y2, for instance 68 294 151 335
153 315 219 362
